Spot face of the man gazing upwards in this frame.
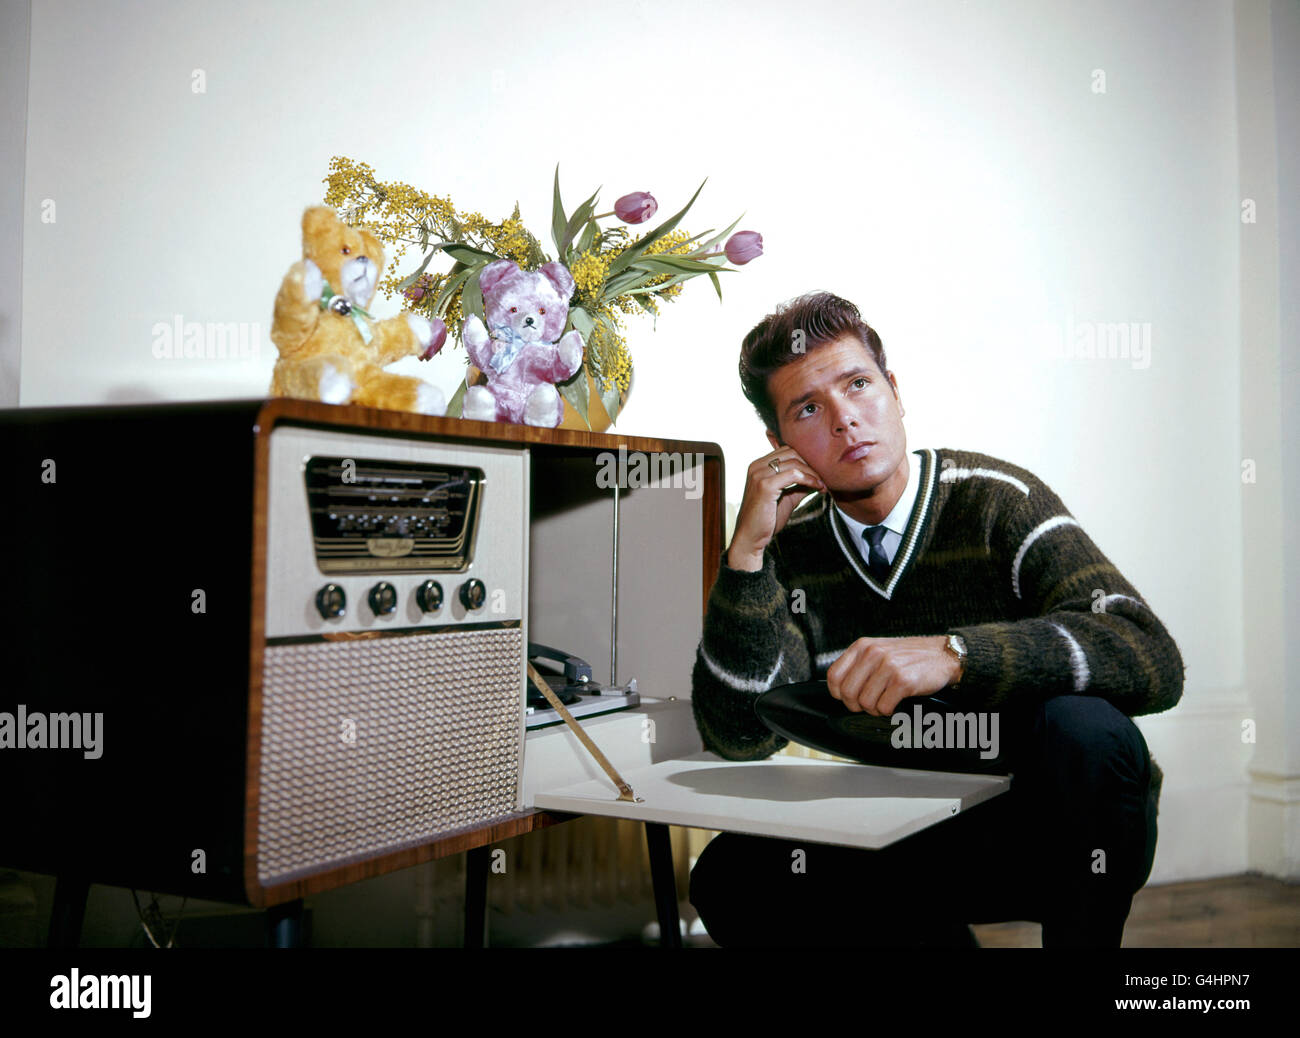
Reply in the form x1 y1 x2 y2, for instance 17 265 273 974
767 336 907 509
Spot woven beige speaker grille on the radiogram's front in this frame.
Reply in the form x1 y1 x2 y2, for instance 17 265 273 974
257 627 523 886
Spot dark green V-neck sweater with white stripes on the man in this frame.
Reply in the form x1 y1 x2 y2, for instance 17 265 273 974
692 449 1183 799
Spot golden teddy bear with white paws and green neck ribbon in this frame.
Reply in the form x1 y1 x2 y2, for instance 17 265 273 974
270 206 447 415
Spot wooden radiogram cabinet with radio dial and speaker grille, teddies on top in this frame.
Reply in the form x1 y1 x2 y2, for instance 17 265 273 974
0 399 723 907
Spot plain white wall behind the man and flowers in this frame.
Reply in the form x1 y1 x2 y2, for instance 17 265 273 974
0 0 1294 881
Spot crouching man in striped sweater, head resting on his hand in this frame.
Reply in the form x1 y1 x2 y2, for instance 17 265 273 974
690 293 1183 947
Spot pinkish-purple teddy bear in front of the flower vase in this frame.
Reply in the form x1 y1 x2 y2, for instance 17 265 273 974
460 260 582 428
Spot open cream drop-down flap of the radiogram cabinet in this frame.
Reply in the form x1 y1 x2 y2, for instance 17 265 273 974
534 753 1011 849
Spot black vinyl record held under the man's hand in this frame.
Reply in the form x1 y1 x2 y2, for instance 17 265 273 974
754 682 1011 775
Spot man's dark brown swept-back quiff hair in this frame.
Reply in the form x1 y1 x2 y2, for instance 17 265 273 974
740 291 888 437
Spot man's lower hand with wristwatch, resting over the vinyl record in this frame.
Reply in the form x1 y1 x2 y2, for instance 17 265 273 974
826 635 961 717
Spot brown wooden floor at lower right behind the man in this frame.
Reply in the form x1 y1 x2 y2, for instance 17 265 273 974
971 875 1300 948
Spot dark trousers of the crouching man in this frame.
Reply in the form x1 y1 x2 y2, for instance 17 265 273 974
690 696 1156 947
